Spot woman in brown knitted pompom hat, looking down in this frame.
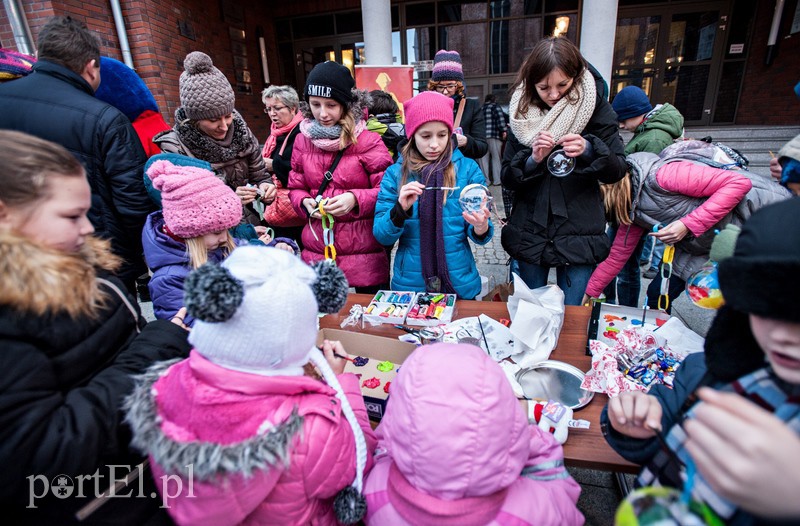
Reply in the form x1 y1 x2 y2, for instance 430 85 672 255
153 51 277 225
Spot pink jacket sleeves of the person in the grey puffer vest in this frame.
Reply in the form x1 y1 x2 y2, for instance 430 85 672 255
586 162 753 298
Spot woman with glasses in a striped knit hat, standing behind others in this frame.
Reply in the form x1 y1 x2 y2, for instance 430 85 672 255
428 49 489 159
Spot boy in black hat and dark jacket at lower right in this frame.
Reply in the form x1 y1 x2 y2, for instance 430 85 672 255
601 199 800 525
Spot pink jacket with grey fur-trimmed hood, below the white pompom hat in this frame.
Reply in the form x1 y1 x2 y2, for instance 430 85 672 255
129 351 376 526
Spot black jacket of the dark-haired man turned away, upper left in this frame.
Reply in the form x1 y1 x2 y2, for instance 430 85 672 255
0 60 155 288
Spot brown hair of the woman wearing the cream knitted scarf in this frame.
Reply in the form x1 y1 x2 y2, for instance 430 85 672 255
511 37 587 113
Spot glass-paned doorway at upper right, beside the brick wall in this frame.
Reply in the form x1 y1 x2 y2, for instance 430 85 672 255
610 1 728 126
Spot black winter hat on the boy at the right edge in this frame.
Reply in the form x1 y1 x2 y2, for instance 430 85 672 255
719 198 800 322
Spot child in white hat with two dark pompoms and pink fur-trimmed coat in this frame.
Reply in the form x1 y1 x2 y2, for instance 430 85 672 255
127 246 375 526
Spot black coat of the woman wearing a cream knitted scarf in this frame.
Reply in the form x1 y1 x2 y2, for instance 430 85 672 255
501 96 626 266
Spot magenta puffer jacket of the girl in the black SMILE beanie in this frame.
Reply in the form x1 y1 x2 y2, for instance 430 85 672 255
289 130 392 287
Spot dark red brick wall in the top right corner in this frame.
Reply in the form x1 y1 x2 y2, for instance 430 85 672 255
736 0 800 126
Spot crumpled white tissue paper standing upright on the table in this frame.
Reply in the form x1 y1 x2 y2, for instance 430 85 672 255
508 274 564 368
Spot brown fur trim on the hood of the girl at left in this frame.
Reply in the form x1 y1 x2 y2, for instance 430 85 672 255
0 232 120 318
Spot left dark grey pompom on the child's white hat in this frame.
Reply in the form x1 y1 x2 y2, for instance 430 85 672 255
183 263 244 323
